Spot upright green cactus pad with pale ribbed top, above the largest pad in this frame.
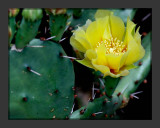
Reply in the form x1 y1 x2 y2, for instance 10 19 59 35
15 9 43 49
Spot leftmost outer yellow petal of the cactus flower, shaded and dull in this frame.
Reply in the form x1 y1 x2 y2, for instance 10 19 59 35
70 36 86 53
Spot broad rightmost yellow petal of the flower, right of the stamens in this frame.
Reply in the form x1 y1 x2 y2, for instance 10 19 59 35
124 40 145 65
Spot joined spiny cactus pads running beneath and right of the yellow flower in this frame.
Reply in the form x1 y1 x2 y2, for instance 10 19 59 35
70 33 151 119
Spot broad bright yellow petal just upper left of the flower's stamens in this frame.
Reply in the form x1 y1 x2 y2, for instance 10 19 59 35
86 21 102 48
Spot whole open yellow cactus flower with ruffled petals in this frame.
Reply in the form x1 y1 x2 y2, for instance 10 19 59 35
70 10 145 78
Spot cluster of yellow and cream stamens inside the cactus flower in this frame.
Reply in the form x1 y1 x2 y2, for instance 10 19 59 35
96 37 127 55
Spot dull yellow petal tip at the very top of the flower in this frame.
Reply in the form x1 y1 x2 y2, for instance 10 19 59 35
94 9 113 19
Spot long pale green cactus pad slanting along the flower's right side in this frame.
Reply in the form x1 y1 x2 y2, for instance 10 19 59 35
115 33 152 100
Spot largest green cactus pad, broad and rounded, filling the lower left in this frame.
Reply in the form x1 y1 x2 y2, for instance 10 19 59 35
9 39 75 119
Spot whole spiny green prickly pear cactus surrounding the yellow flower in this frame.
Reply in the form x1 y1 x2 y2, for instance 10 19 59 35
8 8 151 120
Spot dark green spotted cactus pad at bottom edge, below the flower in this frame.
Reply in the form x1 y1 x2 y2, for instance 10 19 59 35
70 95 122 120
